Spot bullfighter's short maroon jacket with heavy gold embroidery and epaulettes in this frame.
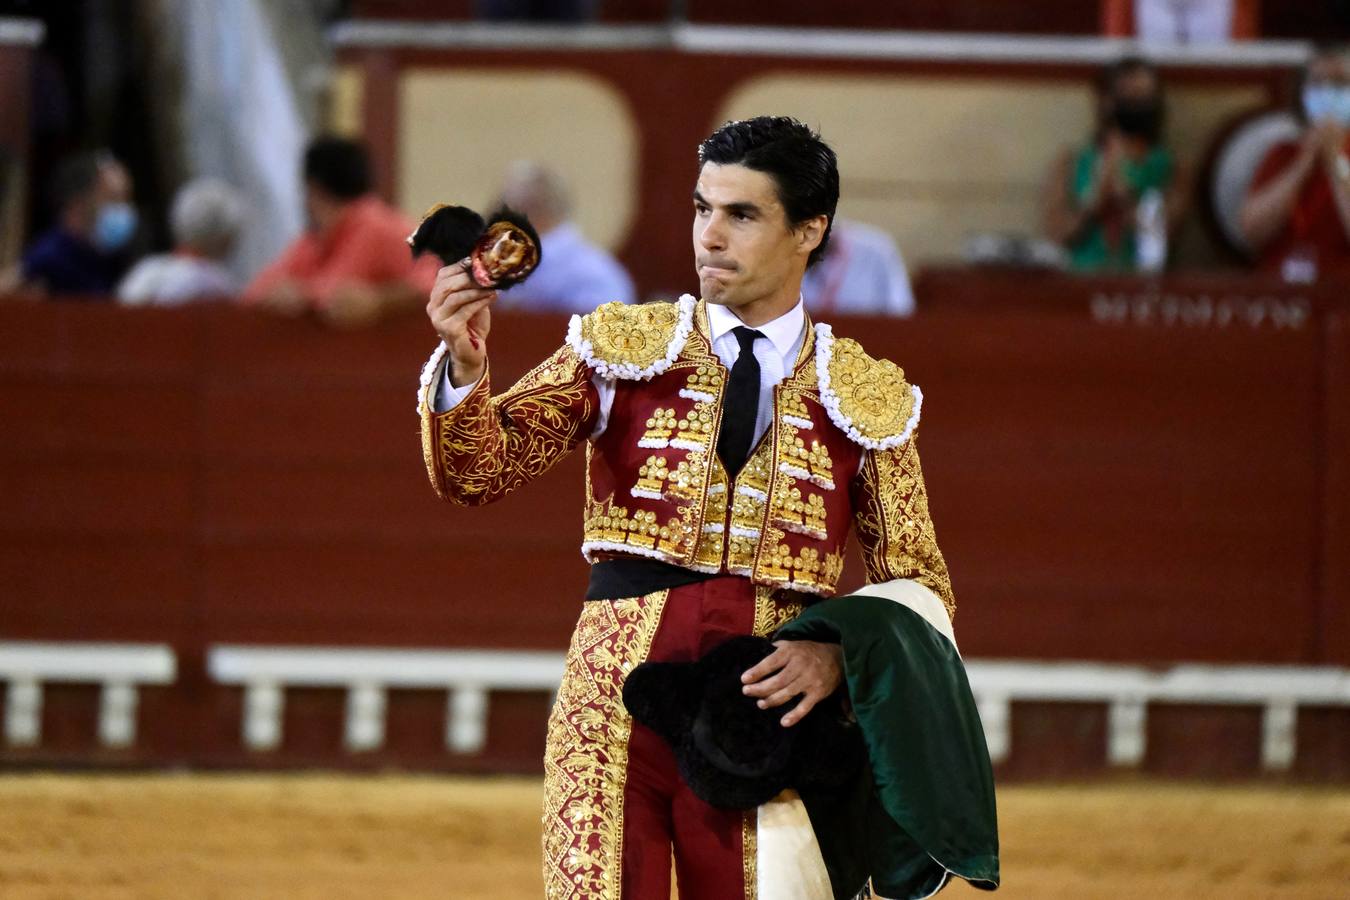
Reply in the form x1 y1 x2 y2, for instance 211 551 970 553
417 296 954 614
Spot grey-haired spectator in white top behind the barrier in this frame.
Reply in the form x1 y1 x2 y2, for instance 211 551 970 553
117 178 243 306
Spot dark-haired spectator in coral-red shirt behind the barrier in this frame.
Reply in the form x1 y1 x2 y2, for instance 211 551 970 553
244 138 439 325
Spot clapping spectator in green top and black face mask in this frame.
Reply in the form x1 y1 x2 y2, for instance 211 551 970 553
1045 57 1188 271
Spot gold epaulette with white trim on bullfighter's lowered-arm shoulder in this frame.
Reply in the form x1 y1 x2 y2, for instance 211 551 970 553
815 324 923 449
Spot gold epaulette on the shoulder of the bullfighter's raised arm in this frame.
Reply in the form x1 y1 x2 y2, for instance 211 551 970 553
567 294 694 381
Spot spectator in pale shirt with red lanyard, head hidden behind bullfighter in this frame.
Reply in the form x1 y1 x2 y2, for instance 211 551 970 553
802 219 914 316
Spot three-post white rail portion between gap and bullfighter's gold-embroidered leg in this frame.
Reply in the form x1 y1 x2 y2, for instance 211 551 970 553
207 646 563 753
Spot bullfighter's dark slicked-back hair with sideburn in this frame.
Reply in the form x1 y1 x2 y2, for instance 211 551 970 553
698 116 840 267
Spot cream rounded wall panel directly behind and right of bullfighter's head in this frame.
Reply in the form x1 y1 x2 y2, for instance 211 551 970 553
710 73 1264 266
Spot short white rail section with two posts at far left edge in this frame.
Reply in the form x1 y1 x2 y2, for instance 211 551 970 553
0 641 177 748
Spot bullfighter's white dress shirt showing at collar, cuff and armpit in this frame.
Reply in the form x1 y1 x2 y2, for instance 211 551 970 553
432 298 806 447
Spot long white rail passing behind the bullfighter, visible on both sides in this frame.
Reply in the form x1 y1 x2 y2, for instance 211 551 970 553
199 646 1350 770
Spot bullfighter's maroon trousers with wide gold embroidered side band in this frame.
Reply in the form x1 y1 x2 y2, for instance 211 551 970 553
544 576 802 900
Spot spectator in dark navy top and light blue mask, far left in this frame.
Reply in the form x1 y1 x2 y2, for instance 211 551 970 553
22 152 139 298
